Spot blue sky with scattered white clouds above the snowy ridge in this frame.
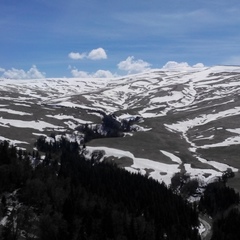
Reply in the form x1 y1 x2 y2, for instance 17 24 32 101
0 0 240 78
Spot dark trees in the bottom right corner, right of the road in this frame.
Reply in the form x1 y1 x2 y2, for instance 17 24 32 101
199 180 240 240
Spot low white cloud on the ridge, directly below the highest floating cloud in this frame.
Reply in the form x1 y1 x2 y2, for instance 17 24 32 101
71 68 116 78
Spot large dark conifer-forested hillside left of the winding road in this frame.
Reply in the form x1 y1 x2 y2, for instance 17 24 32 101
0 139 200 240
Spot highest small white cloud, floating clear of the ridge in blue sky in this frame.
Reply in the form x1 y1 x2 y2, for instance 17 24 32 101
68 48 107 60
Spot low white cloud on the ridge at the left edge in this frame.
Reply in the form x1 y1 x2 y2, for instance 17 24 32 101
1 65 45 79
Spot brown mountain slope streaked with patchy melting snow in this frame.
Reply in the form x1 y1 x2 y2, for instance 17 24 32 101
0 66 240 188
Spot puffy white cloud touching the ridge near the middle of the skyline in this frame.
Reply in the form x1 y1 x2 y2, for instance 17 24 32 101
118 56 151 74
